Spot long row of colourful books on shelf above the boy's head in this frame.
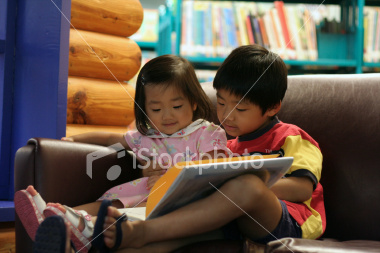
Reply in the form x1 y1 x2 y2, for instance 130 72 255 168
180 1 340 60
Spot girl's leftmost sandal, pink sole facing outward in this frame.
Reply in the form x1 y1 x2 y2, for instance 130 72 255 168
14 190 46 241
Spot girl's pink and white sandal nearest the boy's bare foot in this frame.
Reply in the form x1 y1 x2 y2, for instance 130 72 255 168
44 205 94 253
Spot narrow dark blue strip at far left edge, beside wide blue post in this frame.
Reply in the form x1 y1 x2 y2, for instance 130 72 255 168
0 0 16 199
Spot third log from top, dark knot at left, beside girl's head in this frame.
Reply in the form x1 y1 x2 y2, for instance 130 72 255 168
67 76 135 126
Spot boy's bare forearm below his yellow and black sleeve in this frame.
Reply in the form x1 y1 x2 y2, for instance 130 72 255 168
271 177 313 202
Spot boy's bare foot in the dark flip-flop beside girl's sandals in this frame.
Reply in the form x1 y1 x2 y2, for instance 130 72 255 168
103 207 145 248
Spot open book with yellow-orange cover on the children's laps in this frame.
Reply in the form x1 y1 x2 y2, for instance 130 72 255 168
121 155 293 220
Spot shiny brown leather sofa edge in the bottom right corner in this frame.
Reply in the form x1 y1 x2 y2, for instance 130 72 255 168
265 238 380 253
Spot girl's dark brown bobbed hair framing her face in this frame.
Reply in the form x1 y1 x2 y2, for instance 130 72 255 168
134 55 213 135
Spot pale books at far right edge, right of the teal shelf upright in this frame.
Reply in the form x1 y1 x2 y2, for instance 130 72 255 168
363 6 380 62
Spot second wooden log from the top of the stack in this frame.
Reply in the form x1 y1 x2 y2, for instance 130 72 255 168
69 29 141 81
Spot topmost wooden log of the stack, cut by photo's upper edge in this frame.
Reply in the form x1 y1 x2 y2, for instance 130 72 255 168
71 0 144 37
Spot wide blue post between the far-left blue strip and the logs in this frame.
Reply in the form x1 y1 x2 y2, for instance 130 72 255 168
11 0 71 199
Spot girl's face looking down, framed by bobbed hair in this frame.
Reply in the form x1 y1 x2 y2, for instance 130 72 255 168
144 85 197 135
